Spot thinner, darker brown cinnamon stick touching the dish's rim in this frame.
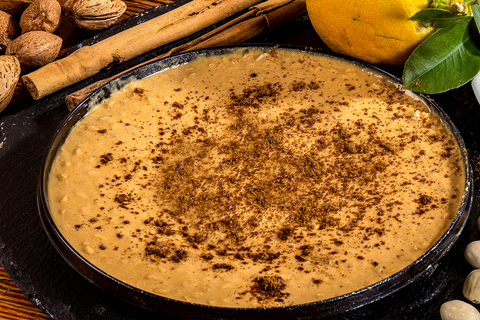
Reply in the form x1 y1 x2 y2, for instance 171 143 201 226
65 0 306 111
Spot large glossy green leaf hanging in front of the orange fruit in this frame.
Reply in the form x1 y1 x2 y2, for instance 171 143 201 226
403 17 480 94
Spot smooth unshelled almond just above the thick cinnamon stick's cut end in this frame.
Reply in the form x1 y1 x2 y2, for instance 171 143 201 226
5 31 63 71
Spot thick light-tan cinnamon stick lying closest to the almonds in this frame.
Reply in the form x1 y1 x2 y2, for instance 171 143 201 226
22 0 262 99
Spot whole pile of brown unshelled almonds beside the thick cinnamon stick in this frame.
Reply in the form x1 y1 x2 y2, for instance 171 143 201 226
0 0 127 112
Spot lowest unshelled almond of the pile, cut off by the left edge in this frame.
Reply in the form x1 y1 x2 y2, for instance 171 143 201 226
0 56 20 112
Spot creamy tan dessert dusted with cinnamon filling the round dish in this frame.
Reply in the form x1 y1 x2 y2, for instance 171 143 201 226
48 49 465 308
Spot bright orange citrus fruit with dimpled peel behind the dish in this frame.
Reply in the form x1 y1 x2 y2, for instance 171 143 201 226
306 0 434 65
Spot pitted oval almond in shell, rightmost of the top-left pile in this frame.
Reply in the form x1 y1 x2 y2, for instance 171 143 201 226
63 0 127 31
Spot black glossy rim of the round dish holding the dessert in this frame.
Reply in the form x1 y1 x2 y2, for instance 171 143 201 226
37 44 473 319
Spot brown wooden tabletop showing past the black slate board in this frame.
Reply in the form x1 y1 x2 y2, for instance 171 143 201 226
0 0 175 320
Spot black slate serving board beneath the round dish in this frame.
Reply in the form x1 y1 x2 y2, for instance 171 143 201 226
0 0 480 320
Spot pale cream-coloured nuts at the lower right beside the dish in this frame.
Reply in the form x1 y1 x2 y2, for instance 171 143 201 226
440 218 480 320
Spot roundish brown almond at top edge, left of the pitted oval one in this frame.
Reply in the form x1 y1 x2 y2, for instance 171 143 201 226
20 0 62 33
